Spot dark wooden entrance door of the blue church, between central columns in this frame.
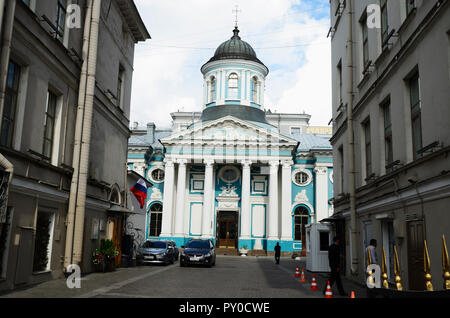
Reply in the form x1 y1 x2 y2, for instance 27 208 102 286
217 211 238 248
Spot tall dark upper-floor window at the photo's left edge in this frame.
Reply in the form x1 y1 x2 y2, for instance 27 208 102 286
0 61 20 147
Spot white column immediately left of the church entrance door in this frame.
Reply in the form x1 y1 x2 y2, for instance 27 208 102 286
202 160 214 238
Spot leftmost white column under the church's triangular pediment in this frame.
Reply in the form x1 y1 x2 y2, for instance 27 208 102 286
160 160 175 237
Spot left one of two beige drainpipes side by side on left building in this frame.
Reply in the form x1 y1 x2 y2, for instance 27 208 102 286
64 0 96 270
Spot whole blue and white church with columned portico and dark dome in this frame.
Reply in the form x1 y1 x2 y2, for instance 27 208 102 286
128 29 333 252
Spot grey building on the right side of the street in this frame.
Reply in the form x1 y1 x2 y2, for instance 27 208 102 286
329 0 450 290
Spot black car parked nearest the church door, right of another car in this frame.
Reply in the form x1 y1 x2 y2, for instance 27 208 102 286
180 239 216 267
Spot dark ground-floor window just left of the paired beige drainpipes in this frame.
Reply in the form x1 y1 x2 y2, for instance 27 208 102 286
33 211 53 272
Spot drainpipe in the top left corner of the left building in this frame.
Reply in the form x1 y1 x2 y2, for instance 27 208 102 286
0 1 16 132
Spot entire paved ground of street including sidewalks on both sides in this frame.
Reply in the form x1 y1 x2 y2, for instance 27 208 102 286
0 256 366 298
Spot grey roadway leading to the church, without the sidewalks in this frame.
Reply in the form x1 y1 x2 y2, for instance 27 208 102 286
85 256 322 298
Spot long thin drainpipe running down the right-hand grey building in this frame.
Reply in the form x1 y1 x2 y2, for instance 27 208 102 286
347 0 358 275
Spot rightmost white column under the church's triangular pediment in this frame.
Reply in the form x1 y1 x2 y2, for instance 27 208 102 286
281 160 293 241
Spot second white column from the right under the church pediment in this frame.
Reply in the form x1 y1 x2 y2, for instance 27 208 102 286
267 161 280 241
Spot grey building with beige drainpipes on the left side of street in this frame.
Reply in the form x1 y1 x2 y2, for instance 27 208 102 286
0 0 150 290
